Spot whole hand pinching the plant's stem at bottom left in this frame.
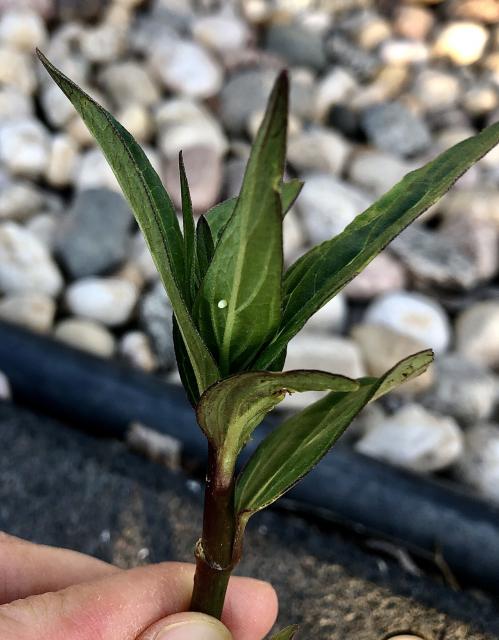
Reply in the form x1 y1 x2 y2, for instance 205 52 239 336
0 532 277 640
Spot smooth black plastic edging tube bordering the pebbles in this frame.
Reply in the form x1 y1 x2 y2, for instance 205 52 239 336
0 323 499 593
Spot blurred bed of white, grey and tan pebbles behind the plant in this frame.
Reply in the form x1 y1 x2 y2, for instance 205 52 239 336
0 0 499 501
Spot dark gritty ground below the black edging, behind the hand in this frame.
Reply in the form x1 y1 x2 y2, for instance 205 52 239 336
0 403 499 640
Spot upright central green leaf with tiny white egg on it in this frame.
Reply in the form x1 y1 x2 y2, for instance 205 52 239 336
195 73 288 376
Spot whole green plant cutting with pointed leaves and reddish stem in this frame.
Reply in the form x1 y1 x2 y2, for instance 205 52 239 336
38 53 499 640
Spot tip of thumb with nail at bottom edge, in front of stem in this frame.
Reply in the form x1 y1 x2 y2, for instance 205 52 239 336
137 612 232 640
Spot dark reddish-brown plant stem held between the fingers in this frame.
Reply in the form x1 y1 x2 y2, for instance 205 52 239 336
191 445 236 618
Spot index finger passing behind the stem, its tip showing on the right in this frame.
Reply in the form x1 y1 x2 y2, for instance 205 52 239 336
0 563 273 640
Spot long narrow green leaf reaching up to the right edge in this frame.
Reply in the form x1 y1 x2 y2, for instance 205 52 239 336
255 123 499 369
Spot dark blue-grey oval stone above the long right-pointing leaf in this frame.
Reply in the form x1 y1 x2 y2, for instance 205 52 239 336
362 102 431 156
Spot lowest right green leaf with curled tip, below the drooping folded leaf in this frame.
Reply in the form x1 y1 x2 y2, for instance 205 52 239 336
236 350 433 519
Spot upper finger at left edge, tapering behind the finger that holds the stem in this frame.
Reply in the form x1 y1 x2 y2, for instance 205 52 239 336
0 532 119 604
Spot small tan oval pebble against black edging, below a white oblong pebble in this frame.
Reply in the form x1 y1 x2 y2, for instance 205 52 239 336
54 318 116 358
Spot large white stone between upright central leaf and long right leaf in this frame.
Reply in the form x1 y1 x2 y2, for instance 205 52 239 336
296 173 370 244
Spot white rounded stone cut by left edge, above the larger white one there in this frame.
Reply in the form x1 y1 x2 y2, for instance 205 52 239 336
0 118 50 178
